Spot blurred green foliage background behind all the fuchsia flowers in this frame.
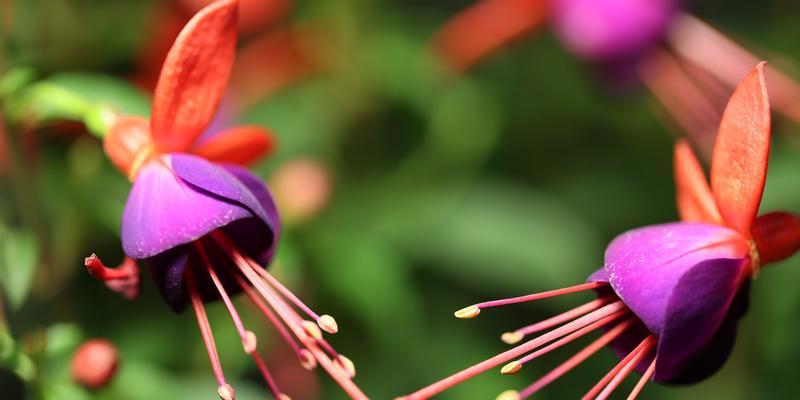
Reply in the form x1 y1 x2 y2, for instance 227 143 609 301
0 0 800 400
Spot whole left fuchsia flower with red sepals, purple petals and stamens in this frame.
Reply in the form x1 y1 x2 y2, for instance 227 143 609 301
87 0 365 400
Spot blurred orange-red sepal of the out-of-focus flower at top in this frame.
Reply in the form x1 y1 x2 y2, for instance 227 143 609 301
433 0 548 71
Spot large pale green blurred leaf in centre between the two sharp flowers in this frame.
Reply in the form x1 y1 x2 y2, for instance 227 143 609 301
396 181 603 294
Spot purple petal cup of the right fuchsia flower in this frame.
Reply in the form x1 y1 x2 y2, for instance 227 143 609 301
593 223 748 381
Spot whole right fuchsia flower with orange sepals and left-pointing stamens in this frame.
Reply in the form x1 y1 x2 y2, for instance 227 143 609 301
407 63 800 399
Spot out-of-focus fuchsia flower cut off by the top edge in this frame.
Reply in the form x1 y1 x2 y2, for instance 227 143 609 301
432 0 800 158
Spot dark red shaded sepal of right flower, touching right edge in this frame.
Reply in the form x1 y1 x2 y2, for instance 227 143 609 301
753 212 800 264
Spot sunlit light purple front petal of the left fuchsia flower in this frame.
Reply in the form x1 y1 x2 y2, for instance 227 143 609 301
122 156 255 259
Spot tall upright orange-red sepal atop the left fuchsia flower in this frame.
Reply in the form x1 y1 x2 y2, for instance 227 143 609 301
150 0 238 152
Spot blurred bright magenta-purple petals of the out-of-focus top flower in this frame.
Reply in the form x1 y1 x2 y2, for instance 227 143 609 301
553 0 679 63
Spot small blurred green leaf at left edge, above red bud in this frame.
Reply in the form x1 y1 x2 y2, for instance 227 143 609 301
0 229 39 308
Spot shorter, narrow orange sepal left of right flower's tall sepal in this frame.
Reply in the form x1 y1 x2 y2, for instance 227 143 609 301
674 139 722 224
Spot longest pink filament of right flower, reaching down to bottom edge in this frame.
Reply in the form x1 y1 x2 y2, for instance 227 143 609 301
407 302 627 400
